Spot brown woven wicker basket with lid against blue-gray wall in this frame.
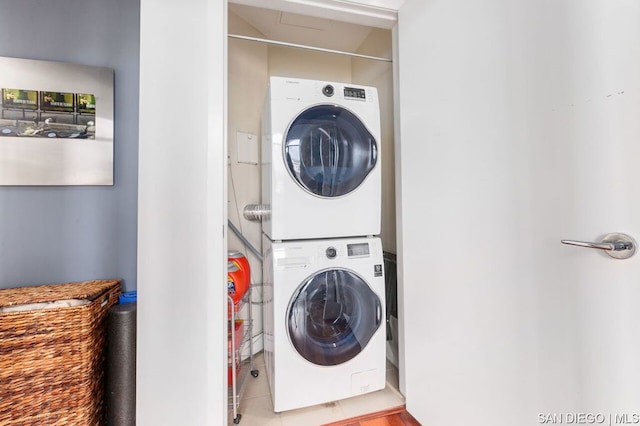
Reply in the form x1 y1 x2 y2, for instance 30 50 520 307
0 280 121 426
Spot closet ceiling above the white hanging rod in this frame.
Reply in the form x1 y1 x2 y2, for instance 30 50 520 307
229 3 373 52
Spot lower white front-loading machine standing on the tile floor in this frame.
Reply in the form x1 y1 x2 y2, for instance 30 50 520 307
263 236 386 412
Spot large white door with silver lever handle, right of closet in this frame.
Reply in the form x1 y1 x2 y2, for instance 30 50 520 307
398 0 640 426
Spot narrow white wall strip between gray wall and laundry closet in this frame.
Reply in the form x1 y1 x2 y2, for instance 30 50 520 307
136 0 227 426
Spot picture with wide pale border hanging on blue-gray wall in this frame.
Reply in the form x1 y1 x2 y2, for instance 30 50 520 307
0 57 113 186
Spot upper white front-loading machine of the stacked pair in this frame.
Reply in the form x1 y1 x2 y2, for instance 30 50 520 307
262 77 381 240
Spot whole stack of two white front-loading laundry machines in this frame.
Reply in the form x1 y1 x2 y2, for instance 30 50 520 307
262 77 386 412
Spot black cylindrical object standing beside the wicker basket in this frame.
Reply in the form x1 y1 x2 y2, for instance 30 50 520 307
105 303 137 426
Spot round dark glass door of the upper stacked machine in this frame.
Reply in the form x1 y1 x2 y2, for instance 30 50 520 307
284 105 378 198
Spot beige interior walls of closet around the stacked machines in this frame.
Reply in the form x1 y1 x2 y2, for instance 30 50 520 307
227 5 396 351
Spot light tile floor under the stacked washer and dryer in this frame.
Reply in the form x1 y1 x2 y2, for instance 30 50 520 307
229 353 405 426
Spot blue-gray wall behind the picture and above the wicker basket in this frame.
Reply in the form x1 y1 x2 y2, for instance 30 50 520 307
0 0 140 290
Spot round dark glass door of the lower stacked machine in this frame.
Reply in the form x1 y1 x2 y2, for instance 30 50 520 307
287 269 382 365
